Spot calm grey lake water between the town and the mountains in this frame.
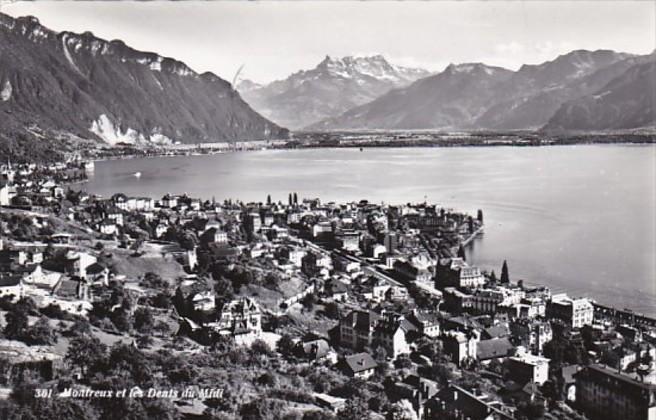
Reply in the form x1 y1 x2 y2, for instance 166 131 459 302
83 145 656 315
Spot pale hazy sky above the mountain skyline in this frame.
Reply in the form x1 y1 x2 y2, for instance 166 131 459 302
5 0 656 82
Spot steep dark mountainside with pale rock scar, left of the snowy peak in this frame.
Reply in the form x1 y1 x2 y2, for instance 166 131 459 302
0 14 288 158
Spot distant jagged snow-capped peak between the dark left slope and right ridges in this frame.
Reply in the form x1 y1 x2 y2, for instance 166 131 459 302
238 55 430 129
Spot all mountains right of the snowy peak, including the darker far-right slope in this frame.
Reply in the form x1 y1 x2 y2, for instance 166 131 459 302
308 50 656 130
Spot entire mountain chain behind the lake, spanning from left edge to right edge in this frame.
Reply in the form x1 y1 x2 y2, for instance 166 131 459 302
0 13 656 162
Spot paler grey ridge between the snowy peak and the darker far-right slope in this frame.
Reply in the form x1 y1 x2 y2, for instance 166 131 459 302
308 50 653 130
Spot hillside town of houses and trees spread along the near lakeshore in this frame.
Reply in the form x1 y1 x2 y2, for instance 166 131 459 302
0 160 656 420
